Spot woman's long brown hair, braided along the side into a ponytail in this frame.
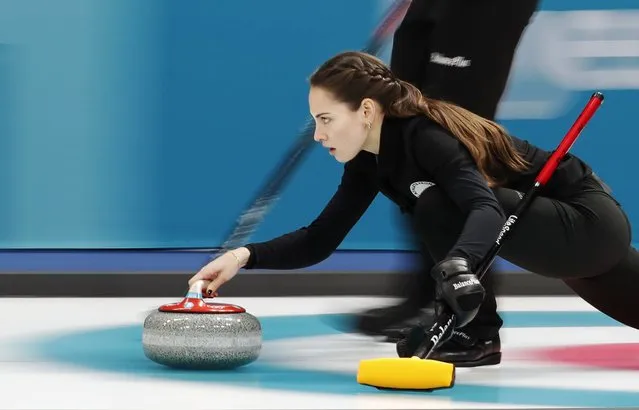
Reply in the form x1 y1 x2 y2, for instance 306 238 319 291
310 51 529 186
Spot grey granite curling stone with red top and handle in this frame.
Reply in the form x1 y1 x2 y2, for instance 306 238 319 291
142 283 262 370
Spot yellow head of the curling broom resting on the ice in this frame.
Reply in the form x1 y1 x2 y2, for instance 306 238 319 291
357 357 455 390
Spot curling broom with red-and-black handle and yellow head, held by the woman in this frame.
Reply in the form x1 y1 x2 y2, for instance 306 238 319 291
357 92 604 390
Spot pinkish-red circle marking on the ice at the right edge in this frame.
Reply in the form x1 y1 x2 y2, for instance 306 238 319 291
531 343 639 370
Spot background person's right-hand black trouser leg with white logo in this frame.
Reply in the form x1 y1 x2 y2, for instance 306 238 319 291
419 0 539 120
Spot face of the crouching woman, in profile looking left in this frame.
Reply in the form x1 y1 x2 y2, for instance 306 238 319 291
309 87 372 163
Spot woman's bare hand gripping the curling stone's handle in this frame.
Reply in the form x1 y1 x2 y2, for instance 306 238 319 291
189 248 250 297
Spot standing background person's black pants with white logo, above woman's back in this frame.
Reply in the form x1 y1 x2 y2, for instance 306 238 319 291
390 0 539 120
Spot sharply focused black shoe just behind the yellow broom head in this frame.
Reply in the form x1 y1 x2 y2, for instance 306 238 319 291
429 329 501 367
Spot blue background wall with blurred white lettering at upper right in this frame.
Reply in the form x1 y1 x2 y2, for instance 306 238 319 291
0 0 639 249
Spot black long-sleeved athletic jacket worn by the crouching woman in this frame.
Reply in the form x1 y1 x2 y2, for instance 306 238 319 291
246 116 591 269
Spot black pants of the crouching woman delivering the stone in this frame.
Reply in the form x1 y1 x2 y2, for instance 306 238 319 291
413 176 639 337
